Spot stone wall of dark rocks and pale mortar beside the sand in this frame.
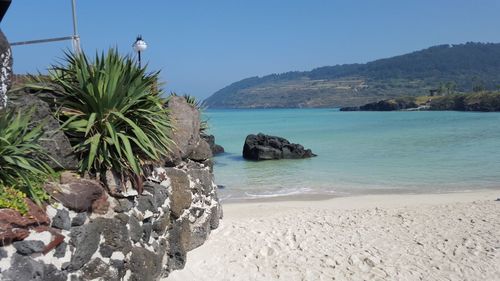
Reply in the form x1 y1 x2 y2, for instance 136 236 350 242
0 94 222 281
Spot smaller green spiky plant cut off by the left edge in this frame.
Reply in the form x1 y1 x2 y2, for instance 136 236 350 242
0 109 54 211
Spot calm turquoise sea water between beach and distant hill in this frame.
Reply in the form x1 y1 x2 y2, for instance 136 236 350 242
205 109 500 200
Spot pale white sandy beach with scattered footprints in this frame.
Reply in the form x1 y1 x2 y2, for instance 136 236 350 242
166 190 500 281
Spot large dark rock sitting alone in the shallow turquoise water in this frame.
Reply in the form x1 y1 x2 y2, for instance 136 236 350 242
243 133 316 161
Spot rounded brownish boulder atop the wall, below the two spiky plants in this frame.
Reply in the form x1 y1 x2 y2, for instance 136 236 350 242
44 179 105 212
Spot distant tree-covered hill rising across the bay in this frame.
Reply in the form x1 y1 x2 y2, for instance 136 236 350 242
205 43 500 108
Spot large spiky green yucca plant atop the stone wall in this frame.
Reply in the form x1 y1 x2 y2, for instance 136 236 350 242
28 49 171 192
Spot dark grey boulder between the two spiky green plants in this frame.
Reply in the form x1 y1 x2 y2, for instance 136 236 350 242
9 91 78 170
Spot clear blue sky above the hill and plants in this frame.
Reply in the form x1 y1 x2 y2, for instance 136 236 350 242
0 0 500 99
